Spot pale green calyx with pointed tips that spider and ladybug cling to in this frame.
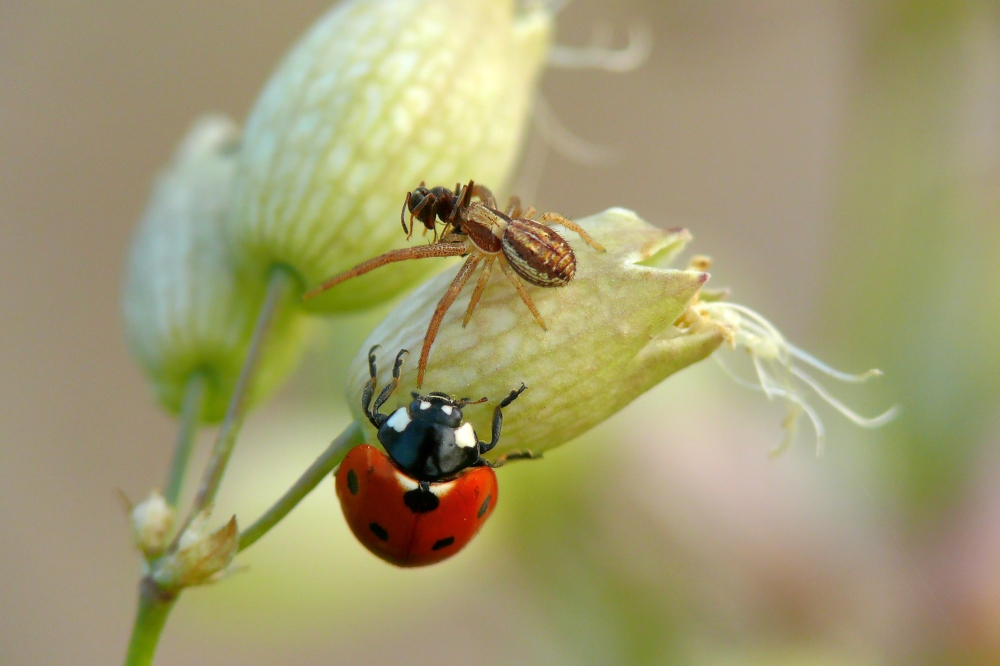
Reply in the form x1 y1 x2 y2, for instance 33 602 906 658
347 209 725 458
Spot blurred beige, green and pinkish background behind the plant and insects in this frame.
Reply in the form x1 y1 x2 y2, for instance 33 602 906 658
0 0 1000 666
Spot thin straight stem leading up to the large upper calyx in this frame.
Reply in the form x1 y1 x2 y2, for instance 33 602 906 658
178 266 295 536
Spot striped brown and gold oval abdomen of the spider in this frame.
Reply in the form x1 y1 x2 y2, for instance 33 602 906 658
502 219 576 287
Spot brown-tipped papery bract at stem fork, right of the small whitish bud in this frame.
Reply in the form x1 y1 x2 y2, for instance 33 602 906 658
150 510 239 591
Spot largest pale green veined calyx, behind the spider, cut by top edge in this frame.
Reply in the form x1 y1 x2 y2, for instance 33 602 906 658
230 0 552 312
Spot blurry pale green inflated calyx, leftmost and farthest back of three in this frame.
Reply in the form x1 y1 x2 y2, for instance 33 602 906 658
123 116 307 422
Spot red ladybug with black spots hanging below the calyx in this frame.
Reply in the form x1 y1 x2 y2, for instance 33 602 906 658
336 345 534 567
